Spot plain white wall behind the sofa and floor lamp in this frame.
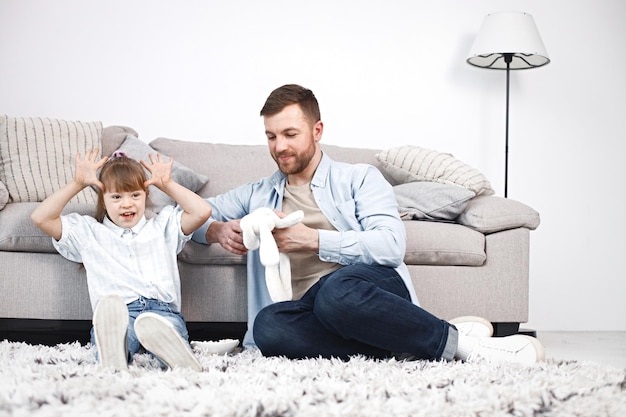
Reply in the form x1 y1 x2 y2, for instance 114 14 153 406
0 0 626 330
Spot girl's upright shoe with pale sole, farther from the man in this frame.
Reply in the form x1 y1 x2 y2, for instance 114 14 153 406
92 295 128 369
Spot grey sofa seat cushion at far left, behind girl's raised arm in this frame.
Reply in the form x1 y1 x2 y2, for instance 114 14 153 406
0 202 96 253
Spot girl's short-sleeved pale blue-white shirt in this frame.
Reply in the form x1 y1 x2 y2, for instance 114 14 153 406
52 206 191 311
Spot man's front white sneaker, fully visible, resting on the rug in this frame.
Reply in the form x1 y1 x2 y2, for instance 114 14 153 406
467 334 545 365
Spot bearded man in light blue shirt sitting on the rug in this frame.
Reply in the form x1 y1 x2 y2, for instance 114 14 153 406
194 85 543 363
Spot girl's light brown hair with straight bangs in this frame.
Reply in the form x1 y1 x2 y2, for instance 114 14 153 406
96 155 149 222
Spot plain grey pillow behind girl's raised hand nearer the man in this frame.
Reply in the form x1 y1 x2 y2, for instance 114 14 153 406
113 135 209 213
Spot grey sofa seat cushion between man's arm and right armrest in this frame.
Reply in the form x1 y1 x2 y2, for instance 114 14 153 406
403 220 487 266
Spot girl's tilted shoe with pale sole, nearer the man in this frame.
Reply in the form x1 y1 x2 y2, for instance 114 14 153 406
135 312 202 371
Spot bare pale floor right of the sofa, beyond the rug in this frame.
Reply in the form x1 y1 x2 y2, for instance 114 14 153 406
537 331 626 368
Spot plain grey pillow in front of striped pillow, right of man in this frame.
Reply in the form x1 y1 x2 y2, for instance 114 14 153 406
393 182 476 221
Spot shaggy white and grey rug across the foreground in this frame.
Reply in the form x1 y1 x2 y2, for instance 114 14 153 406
0 341 626 417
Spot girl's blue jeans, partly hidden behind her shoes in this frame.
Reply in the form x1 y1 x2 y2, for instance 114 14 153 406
91 297 189 360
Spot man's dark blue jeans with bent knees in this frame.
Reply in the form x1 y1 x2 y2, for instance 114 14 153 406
253 264 458 360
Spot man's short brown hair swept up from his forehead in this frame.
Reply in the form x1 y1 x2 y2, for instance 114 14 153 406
261 84 321 125
